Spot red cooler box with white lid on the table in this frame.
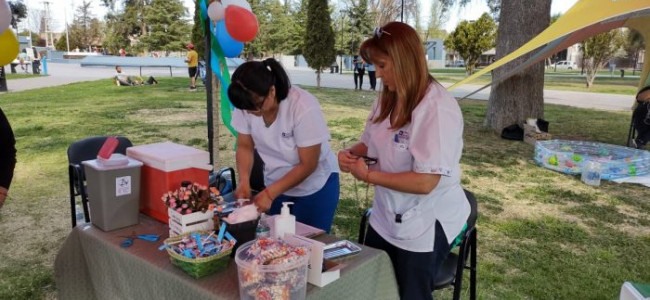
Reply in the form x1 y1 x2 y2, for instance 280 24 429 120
126 142 212 223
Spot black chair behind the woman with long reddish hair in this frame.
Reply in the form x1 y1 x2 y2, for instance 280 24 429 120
358 190 478 300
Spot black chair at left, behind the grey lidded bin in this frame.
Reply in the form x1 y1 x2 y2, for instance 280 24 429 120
68 136 133 228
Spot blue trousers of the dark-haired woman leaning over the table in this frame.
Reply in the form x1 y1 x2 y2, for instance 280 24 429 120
269 173 340 233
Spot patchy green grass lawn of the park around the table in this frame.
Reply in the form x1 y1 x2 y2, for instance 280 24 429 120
0 78 650 299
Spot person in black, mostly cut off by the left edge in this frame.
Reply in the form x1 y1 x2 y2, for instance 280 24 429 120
0 109 16 209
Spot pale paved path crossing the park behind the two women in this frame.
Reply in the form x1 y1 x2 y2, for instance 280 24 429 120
6 63 634 111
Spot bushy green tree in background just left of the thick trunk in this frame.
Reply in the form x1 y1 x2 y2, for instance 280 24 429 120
445 13 496 75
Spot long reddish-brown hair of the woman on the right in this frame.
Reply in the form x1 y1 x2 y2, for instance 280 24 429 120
359 22 435 129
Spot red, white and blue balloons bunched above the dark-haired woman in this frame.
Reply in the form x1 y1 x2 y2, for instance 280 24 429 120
208 0 259 57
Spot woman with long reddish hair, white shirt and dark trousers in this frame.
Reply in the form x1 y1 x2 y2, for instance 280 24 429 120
338 22 470 299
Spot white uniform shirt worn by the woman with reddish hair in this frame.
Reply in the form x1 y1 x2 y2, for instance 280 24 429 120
361 82 470 252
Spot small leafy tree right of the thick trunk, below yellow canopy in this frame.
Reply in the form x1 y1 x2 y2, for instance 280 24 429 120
580 29 624 88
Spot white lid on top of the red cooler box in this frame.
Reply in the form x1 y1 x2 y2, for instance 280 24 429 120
126 142 212 172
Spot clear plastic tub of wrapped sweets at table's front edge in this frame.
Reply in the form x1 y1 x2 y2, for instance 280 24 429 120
235 241 309 300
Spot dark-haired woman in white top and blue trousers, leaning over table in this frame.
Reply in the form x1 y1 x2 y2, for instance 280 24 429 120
228 58 339 232
